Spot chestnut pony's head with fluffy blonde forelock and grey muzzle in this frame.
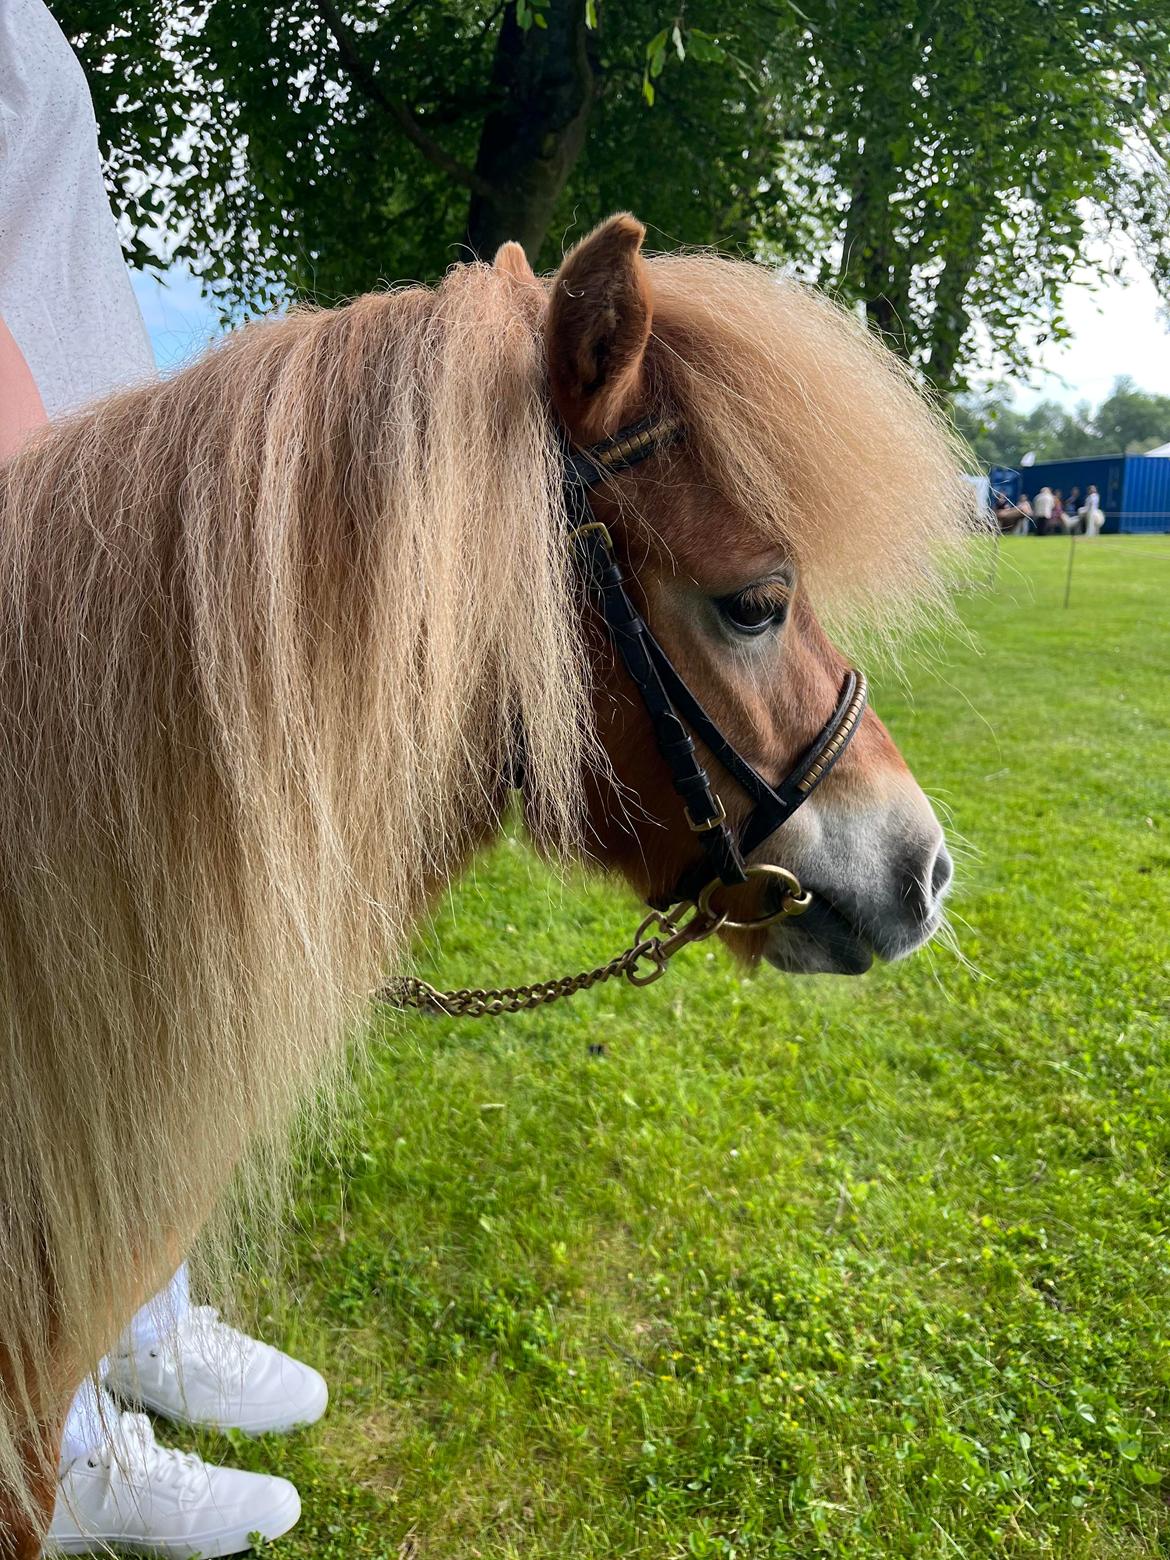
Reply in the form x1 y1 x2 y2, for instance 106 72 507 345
527 215 972 973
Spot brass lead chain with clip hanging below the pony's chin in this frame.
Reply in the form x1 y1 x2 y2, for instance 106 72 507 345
373 903 727 1019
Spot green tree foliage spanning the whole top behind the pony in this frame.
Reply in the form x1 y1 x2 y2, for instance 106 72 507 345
58 0 1170 393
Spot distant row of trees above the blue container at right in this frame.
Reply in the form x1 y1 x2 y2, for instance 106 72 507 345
955 376 1170 466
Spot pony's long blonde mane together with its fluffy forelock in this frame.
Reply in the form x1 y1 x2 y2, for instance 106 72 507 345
0 249 958 1499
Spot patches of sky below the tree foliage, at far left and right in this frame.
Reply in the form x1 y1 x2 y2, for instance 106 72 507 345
134 249 1170 408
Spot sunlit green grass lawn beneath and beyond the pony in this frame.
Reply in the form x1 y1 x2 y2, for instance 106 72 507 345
215 538 1170 1560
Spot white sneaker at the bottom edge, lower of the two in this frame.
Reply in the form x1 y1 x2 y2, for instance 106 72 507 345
47 1413 301 1560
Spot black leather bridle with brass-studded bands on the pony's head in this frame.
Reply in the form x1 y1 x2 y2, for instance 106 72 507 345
563 418 867 925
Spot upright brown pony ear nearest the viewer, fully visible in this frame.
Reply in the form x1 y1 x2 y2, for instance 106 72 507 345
546 212 652 445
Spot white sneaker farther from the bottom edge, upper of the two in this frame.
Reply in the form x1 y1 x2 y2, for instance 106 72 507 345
106 1306 329 1435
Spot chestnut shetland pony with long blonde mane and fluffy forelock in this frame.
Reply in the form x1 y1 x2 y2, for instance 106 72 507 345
0 217 970 1560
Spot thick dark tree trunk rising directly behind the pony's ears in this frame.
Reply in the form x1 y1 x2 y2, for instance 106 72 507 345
466 0 594 262
